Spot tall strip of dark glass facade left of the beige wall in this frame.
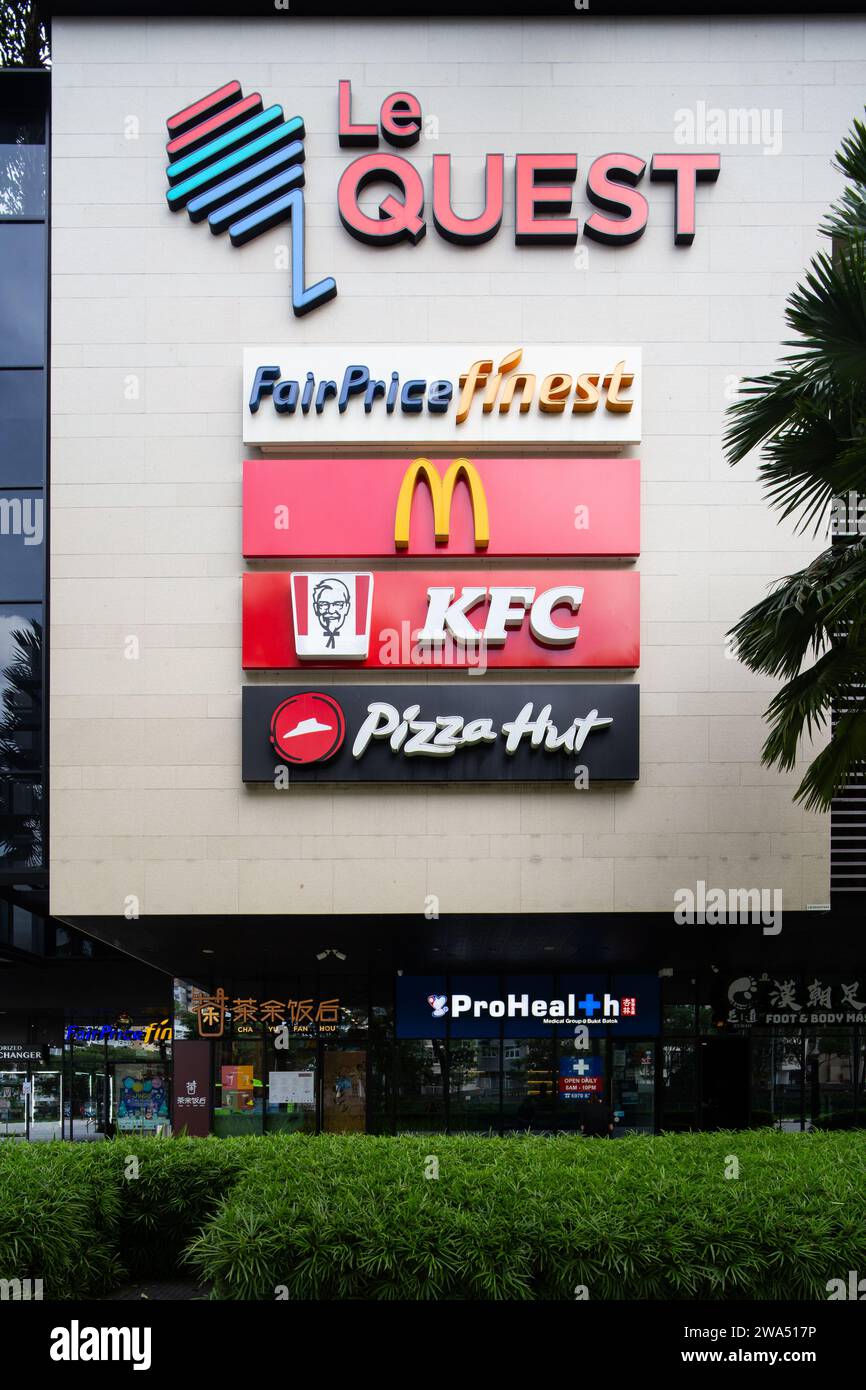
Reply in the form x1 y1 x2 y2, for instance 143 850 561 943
0 71 49 891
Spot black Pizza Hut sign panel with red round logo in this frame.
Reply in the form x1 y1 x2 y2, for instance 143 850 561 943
243 678 639 788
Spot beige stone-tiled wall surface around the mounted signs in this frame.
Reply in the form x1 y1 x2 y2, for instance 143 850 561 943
50 17 866 916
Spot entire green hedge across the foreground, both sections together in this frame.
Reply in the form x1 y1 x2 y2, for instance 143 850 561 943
0 1130 866 1301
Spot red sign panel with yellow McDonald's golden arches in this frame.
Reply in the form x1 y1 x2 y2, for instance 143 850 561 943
243 457 641 559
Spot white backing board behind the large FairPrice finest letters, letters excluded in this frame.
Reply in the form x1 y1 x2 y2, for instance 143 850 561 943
242 343 642 453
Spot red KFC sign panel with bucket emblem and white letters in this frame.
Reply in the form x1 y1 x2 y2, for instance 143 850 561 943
243 569 639 670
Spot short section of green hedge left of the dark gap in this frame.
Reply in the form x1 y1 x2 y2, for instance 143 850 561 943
0 1141 124 1298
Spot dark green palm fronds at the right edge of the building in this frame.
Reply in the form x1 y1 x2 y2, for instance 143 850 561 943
726 121 866 810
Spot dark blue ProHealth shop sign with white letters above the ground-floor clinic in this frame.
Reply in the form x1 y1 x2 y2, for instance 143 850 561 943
396 974 659 1038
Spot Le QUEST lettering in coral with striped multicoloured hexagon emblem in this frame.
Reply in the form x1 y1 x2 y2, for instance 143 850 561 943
165 79 721 316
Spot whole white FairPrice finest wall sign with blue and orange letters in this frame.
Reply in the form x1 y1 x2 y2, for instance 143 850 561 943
243 343 641 453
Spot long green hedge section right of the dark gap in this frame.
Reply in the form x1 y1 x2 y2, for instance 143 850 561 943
188 1130 866 1300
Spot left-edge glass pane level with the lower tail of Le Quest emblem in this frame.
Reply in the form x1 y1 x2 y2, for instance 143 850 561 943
0 222 46 367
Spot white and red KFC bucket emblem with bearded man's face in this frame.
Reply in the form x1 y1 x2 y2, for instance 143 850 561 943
292 574 373 660
